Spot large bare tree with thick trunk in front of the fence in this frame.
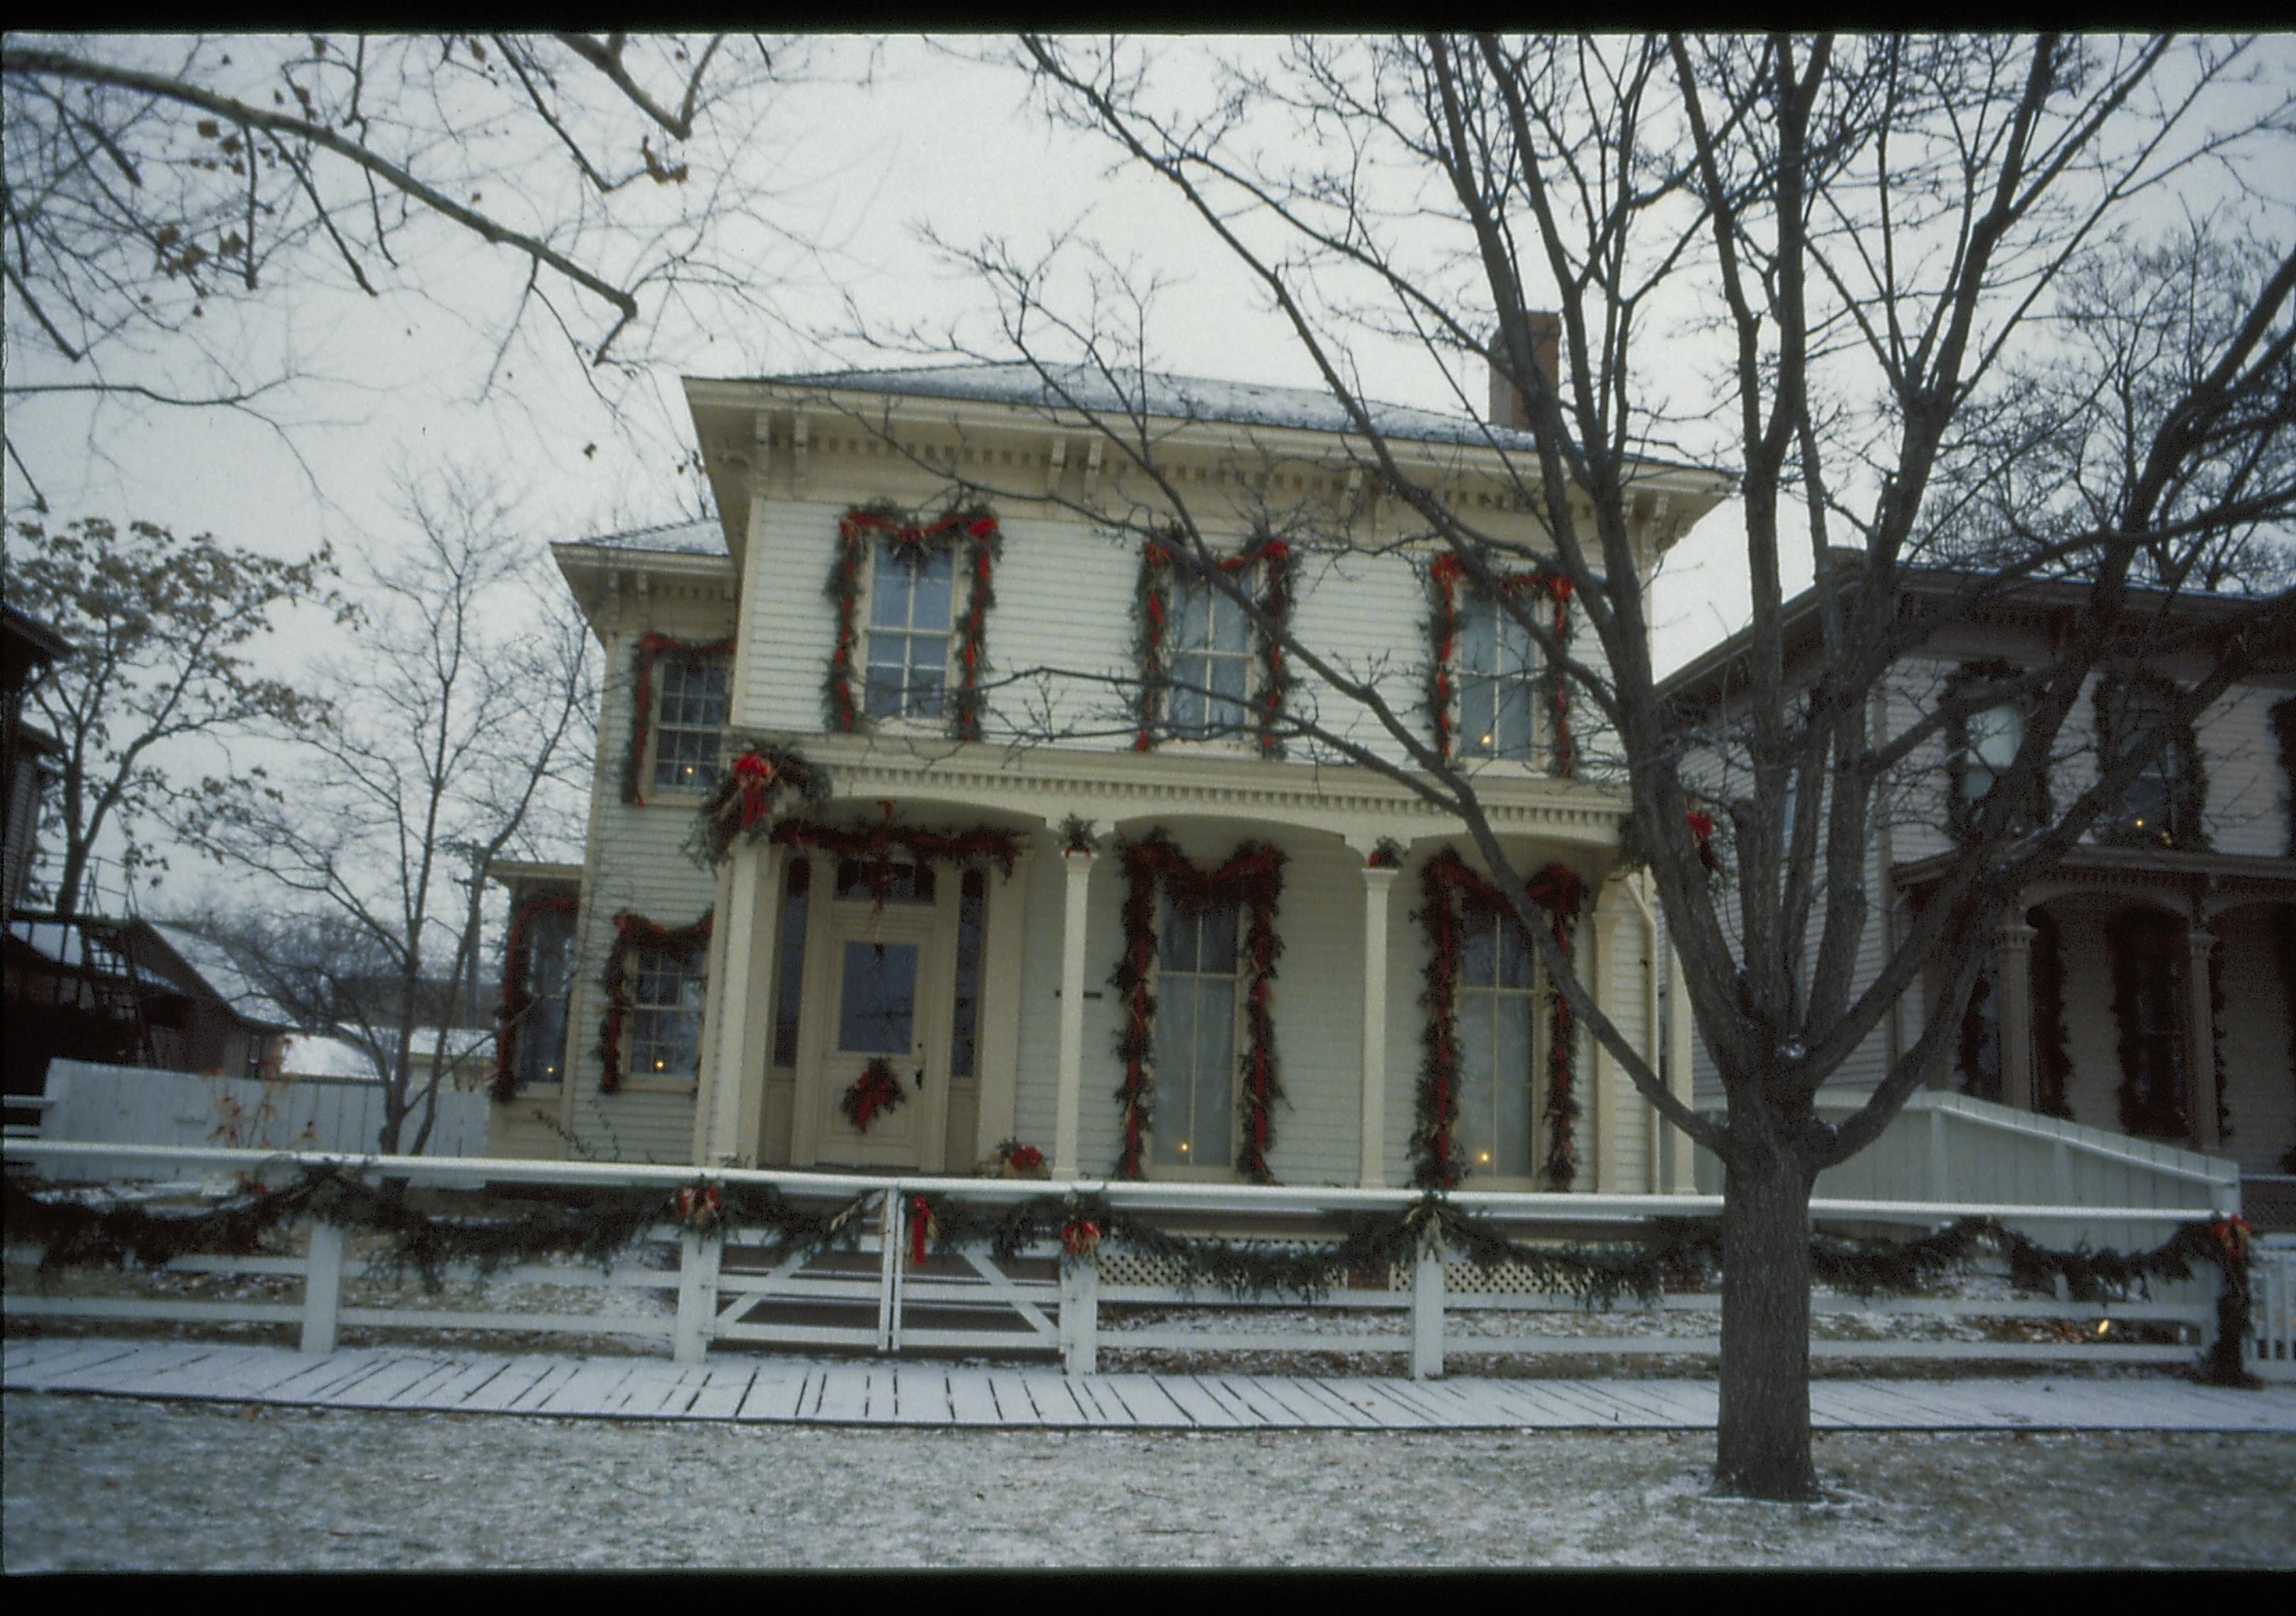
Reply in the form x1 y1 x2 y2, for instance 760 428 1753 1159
900 37 2296 1499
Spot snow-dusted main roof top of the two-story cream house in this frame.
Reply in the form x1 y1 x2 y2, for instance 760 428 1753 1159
725 360 1531 448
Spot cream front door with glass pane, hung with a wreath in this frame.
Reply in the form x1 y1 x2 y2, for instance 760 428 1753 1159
790 865 953 1173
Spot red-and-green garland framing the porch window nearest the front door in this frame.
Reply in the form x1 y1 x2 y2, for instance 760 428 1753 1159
1109 829 1283 1184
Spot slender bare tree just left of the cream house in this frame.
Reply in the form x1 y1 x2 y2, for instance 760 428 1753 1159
179 461 597 1152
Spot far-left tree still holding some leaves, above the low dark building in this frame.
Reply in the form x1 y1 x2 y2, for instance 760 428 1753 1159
7 517 349 916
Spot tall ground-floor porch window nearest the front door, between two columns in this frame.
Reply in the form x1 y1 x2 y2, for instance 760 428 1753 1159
1150 895 1242 1168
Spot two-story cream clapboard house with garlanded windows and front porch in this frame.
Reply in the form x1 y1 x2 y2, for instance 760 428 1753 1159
491 365 1724 1191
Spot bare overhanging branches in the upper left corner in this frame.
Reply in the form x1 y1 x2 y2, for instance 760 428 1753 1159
0 32 826 507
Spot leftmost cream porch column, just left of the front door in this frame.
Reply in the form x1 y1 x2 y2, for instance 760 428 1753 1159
693 838 783 1166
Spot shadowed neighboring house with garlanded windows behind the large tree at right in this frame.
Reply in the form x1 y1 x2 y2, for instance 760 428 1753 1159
1662 556 2296 1221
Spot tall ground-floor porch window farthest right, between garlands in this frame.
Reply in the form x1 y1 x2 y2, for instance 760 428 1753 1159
1451 914 1538 1177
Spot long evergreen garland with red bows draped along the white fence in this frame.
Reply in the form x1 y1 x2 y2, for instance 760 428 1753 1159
4 1162 2252 1384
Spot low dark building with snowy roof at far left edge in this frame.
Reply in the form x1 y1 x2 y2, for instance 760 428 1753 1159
4 916 291 1095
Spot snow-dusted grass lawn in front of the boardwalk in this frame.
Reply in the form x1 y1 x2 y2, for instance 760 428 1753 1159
0 1396 2296 1572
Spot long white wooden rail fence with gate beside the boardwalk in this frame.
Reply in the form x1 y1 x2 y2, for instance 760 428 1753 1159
4 1141 2259 1377
